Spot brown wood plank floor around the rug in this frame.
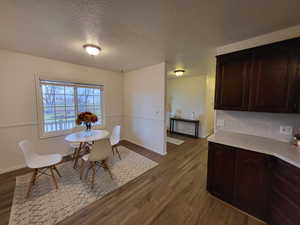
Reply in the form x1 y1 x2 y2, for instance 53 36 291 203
0 135 264 225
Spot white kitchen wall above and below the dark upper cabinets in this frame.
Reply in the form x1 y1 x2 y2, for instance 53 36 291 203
215 25 300 141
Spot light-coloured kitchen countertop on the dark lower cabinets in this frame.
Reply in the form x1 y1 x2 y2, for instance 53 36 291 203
208 131 300 168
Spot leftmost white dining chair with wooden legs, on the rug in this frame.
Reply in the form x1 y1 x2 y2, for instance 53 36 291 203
19 140 62 198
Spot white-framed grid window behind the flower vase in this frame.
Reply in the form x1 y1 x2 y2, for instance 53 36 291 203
40 80 103 136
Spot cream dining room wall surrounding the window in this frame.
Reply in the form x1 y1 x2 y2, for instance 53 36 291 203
0 50 123 173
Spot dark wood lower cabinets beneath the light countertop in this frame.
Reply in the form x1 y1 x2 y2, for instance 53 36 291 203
207 142 300 225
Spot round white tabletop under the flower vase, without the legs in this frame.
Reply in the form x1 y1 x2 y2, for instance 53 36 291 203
65 130 109 142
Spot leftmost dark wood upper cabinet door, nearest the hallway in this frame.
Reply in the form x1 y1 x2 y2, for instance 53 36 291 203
215 51 252 110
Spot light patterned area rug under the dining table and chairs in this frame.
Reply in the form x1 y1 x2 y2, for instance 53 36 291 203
9 147 157 225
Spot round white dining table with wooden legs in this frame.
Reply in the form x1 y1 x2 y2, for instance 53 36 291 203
65 130 109 169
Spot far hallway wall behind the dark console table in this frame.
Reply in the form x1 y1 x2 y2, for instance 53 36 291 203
167 76 206 137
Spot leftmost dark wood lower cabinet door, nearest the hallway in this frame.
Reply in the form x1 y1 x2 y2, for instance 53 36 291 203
207 143 235 202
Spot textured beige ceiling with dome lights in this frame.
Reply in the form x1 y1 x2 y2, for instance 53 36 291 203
0 0 300 75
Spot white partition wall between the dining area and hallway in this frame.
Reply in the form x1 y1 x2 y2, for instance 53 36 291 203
124 63 166 154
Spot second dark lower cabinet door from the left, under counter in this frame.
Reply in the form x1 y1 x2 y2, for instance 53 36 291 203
234 150 271 220
